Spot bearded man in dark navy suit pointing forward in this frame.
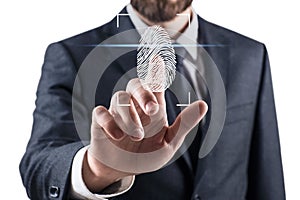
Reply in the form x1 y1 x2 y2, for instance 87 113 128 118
20 0 285 200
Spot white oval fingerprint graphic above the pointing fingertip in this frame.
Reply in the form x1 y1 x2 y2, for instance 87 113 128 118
137 25 176 92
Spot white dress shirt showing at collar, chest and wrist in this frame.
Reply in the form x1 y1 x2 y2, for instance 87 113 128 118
71 4 198 200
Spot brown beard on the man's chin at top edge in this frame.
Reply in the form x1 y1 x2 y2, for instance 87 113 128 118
131 0 193 23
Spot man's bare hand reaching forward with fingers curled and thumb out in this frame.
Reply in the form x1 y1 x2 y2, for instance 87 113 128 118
83 79 207 191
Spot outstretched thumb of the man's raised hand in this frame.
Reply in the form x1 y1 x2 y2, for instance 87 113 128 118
165 100 208 149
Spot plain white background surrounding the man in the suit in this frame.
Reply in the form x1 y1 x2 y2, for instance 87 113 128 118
0 0 300 200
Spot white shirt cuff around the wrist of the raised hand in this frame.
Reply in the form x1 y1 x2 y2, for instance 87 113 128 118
70 146 135 200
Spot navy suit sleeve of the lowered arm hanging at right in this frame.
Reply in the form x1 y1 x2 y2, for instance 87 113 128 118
247 46 285 200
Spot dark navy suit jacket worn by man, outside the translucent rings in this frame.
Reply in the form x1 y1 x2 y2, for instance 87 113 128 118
20 6 285 200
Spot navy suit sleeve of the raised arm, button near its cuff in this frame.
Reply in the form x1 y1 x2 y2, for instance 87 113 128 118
20 43 83 199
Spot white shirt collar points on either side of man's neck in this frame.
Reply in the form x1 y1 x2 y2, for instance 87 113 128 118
126 4 199 60
